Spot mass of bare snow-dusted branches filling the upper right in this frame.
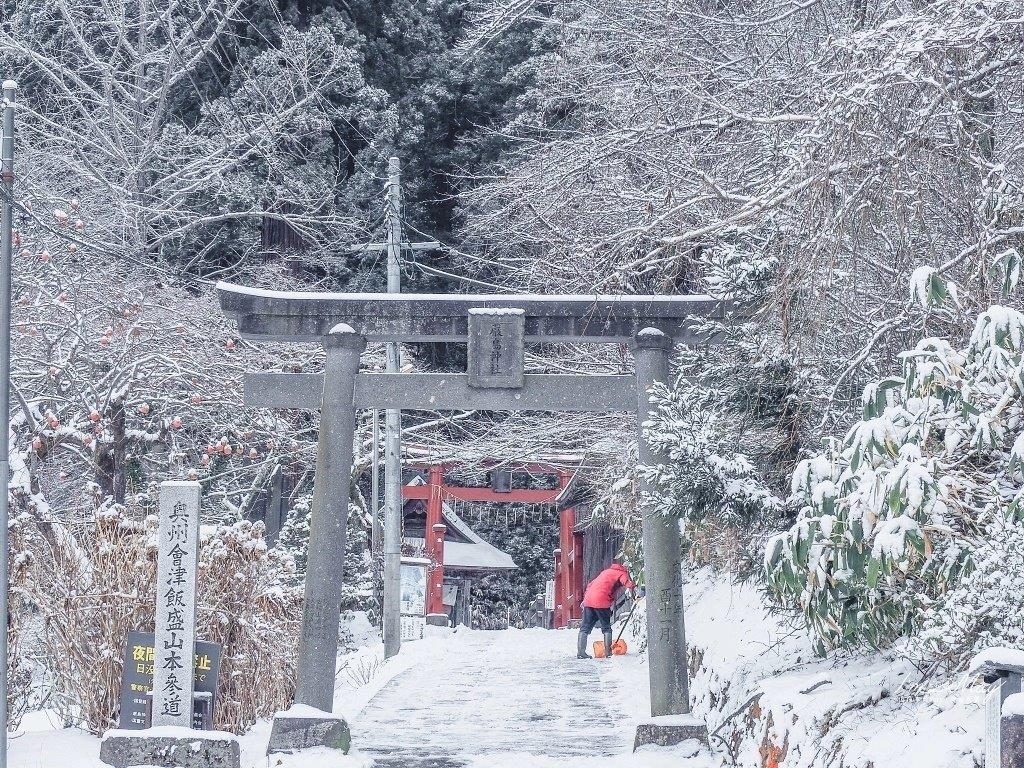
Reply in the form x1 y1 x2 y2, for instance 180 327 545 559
463 0 1024 432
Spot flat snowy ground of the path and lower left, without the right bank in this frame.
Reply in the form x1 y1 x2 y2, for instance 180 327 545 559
10 630 719 768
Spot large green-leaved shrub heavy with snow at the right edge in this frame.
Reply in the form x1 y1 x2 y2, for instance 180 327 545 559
765 306 1024 653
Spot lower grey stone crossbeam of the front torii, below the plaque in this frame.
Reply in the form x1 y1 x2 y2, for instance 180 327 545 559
245 373 637 413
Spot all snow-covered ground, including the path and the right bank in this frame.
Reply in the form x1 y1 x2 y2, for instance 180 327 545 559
4 572 982 768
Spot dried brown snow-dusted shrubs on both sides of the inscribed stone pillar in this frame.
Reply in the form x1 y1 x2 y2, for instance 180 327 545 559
25 503 302 733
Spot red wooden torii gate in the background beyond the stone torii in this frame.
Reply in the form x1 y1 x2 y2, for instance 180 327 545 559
401 462 584 628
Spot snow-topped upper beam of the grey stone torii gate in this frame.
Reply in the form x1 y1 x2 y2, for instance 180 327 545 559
217 283 730 344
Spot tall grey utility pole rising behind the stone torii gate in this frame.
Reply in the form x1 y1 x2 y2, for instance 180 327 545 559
382 158 402 658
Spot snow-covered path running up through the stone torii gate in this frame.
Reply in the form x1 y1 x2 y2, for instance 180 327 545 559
352 630 635 768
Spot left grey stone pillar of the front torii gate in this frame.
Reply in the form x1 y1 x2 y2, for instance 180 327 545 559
295 324 367 712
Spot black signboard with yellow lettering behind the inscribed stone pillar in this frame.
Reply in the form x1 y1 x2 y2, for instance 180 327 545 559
120 631 220 730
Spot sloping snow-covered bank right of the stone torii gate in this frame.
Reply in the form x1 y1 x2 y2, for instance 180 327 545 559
686 572 983 768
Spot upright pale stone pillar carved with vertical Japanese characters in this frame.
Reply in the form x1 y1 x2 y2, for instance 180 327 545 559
153 481 200 728
